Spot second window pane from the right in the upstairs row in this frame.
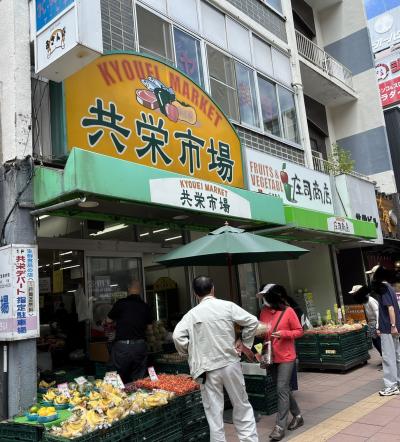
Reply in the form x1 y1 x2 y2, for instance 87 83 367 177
258 77 282 137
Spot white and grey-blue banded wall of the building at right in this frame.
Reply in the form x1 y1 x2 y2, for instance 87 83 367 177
314 0 396 193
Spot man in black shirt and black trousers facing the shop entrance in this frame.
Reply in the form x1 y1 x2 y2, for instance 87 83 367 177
107 280 151 384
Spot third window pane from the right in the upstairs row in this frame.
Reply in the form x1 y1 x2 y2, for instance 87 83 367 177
236 63 259 126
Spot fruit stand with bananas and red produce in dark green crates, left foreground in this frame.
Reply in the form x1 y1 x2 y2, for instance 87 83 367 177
0 375 210 442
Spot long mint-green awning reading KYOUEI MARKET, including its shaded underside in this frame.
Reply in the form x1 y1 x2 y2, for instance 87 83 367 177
34 148 285 228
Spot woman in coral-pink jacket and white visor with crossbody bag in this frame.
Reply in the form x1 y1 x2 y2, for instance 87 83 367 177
258 284 304 440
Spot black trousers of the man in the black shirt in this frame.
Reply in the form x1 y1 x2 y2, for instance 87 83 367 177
111 341 147 384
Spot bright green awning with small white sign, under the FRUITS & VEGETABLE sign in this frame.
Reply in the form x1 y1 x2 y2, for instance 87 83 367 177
257 206 377 244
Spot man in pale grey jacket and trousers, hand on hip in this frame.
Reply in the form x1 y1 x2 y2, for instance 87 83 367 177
173 276 258 442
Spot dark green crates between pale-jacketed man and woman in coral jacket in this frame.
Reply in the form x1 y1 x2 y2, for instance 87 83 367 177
242 362 278 415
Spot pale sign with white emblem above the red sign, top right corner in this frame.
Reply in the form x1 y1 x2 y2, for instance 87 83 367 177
368 7 400 53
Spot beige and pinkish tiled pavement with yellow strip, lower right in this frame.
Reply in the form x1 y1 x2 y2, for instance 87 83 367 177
225 350 400 442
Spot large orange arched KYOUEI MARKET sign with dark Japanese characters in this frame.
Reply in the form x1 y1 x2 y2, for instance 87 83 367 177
64 54 244 188
